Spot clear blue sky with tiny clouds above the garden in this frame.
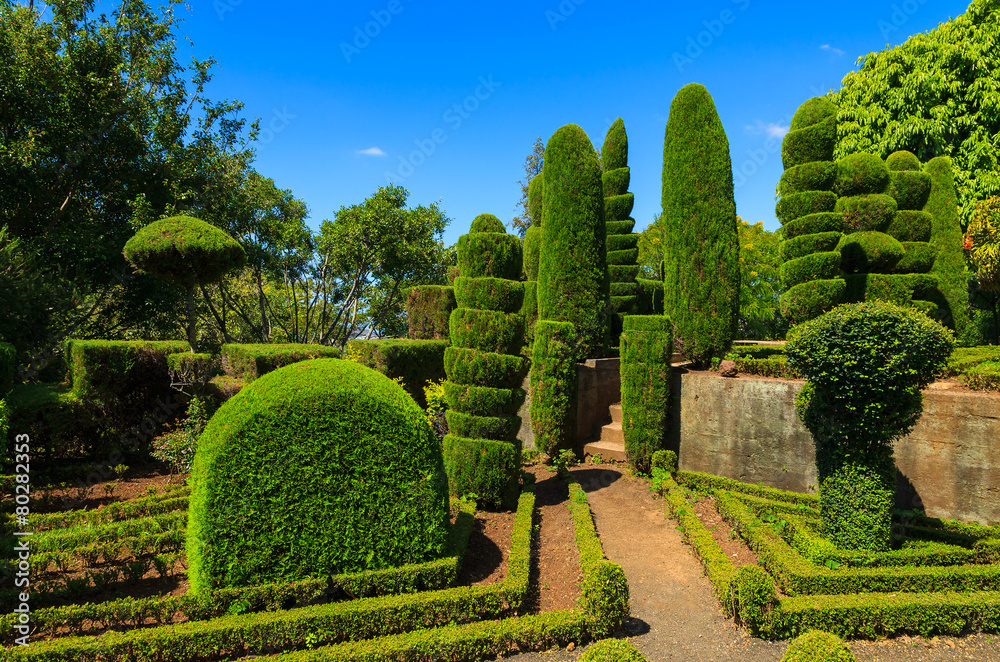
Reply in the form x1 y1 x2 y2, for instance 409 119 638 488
164 0 968 244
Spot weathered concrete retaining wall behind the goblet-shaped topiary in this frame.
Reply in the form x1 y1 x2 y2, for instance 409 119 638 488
667 370 1000 524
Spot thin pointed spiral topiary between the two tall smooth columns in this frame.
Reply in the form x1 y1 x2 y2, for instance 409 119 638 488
601 117 639 345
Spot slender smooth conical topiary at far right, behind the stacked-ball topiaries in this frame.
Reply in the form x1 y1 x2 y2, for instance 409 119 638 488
911 156 969 338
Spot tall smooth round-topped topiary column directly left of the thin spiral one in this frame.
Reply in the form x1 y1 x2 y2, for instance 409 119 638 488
538 124 609 361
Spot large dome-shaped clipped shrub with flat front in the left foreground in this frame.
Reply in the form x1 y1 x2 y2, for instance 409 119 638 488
187 359 448 593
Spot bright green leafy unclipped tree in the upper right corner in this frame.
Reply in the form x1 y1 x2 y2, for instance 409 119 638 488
834 0 1000 231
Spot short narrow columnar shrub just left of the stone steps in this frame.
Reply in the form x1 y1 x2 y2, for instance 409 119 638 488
530 320 576 455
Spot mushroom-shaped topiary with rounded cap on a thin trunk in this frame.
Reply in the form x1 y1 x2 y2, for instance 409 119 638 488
123 216 246 353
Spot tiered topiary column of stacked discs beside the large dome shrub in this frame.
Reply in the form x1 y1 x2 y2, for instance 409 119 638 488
444 214 527 508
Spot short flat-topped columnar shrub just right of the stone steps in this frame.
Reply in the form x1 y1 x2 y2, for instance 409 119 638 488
619 315 673 474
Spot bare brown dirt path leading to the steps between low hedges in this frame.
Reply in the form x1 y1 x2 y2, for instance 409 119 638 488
512 465 1000 662
